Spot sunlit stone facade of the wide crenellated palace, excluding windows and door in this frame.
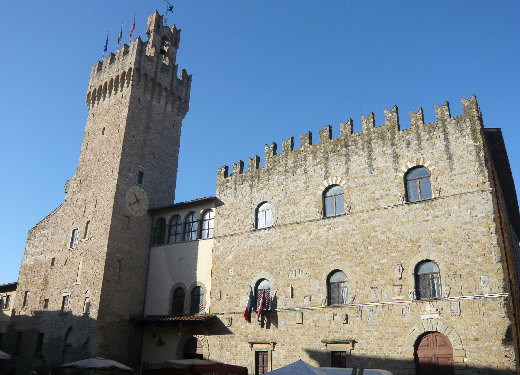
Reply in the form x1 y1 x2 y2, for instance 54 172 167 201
208 97 514 374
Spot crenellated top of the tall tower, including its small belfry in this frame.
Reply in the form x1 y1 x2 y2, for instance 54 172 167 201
85 11 191 116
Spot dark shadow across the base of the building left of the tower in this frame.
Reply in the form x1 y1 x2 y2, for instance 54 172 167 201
0 310 98 375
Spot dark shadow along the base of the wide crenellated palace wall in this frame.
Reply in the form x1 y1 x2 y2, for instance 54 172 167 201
305 350 516 375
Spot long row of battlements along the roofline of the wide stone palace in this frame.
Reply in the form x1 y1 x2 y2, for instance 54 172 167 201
218 95 482 181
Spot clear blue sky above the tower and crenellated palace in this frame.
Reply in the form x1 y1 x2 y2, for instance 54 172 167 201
0 0 520 283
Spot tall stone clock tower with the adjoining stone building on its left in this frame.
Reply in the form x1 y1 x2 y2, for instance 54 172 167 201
4 11 191 373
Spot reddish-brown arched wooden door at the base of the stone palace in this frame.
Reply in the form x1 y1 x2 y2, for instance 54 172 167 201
415 332 455 375
